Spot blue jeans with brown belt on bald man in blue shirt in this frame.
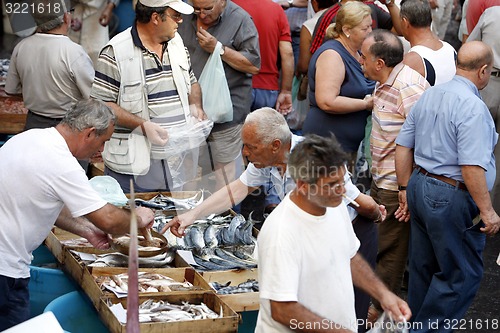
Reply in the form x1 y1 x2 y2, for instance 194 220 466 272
407 171 486 333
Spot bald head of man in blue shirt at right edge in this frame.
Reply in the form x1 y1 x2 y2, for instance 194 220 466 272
457 41 493 90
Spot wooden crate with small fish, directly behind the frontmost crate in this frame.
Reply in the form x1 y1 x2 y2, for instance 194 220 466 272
81 267 211 308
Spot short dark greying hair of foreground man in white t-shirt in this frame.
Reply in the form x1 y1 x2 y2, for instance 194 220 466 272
288 134 347 184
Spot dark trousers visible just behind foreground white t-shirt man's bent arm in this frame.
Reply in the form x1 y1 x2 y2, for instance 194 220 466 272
352 215 378 333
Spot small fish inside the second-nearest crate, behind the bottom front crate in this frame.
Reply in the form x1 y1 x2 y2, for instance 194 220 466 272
95 272 201 294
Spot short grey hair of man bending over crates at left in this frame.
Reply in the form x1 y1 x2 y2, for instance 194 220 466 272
61 99 116 135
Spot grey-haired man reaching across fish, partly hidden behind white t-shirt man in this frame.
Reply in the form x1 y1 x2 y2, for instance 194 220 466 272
162 107 386 237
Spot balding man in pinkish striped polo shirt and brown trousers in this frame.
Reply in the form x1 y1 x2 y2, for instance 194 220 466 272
361 30 429 322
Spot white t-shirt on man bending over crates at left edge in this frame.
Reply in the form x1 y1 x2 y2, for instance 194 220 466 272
0 127 106 278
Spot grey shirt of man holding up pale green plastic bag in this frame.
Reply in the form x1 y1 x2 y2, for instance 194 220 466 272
178 0 260 131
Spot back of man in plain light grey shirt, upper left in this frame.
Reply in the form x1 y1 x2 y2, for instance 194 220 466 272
5 33 94 118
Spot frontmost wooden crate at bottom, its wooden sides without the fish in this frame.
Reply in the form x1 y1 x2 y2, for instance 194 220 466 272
99 291 239 333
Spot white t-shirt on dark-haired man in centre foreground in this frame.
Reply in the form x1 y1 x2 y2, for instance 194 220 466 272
255 194 360 333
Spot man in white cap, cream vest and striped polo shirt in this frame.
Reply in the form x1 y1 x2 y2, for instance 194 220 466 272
91 0 206 192
